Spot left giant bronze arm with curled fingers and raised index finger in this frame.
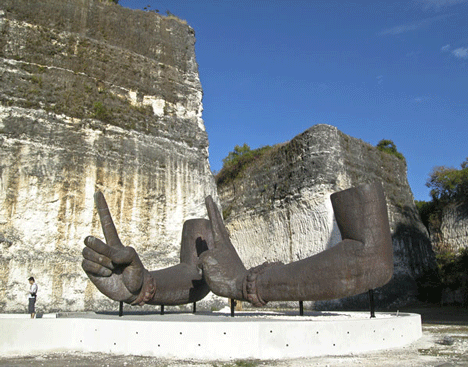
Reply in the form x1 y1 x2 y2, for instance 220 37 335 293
82 192 213 305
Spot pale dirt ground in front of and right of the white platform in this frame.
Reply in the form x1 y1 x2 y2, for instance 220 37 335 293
0 307 468 367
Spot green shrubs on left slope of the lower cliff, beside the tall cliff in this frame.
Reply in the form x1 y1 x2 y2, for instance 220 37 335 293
215 143 271 185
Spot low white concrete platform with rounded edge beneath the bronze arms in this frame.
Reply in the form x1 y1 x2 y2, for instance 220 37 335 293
0 311 422 360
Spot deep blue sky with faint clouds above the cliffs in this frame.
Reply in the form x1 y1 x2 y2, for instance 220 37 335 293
119 0 468 200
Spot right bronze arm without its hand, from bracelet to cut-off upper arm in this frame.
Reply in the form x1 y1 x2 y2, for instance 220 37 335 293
249 184 393 302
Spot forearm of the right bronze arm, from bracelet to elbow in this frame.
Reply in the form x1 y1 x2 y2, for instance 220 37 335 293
250 240 393 304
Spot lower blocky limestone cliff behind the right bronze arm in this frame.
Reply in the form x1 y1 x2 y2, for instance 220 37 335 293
218 125 435 307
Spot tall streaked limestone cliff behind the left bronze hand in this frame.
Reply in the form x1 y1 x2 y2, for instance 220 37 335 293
0 0 216 312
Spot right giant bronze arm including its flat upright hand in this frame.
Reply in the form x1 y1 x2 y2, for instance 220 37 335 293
200 183 393 306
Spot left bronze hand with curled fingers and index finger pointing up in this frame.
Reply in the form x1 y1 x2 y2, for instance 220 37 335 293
81 192 148 303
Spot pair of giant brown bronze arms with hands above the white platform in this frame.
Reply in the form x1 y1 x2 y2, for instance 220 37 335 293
82 183 393 307
